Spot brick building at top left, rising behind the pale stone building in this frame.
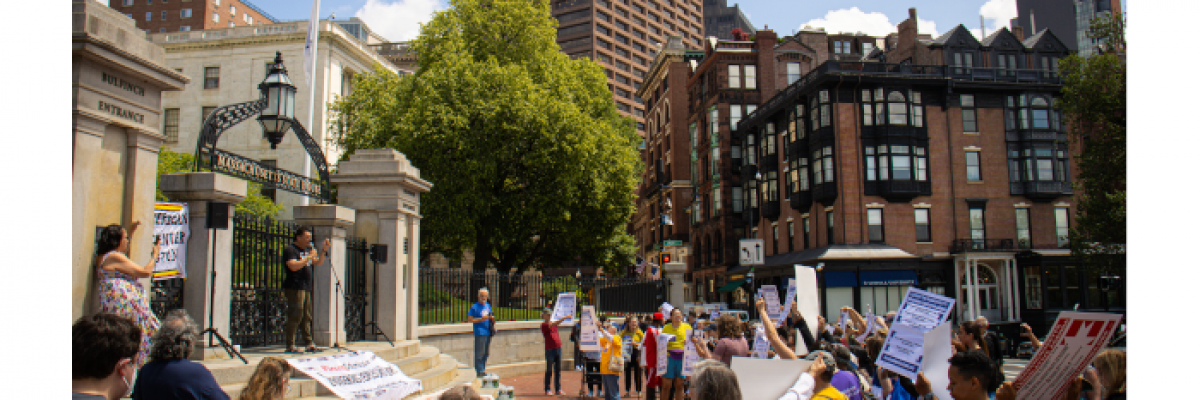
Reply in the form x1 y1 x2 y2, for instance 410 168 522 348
108 0 275 34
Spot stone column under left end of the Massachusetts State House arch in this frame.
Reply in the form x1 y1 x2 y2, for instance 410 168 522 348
161 172 246 359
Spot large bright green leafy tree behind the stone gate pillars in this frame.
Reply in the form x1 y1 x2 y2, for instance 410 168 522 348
332 0 640 270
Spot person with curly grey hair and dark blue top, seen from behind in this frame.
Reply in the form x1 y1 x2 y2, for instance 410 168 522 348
133 309 229 400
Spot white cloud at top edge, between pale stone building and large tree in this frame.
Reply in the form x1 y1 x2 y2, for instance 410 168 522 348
354 0 445 42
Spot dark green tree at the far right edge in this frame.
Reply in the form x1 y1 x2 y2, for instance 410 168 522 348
1060 16 1127 273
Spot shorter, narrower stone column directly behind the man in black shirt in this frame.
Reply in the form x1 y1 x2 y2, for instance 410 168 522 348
292 204 354 346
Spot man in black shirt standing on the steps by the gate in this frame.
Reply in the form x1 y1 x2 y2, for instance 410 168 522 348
283 227 329 353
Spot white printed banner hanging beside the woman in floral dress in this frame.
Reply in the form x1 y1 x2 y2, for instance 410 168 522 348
154 202 191 281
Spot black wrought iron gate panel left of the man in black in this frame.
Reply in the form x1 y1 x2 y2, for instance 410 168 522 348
229 214 302 347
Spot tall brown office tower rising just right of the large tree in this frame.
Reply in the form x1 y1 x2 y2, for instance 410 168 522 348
551 0 704 137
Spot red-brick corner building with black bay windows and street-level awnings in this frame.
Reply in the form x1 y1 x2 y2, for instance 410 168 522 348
724 10 1124 336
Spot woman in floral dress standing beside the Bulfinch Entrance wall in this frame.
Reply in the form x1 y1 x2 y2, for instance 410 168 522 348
96 222 158 369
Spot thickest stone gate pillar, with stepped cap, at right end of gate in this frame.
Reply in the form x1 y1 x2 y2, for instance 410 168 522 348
330 149 433 340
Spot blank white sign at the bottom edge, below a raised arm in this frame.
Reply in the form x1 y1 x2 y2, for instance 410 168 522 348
730 357 812 400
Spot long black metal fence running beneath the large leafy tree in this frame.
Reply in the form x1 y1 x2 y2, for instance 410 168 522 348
418 268 665 326
